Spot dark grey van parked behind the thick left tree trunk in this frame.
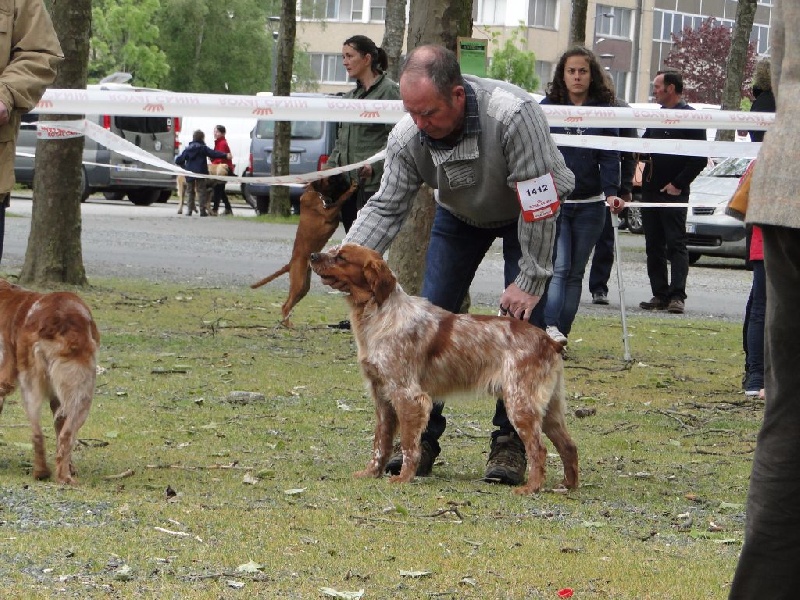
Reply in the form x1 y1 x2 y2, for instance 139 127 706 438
14 83 180 206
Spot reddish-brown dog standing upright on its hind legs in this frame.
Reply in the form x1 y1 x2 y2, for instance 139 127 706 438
250 175 358 327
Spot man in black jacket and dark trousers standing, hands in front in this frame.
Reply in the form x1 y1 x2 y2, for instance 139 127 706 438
639 71 708 314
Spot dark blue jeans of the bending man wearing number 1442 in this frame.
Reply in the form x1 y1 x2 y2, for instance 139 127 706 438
422 206 544 453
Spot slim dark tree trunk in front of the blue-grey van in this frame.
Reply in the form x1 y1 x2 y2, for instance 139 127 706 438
269 0 297 215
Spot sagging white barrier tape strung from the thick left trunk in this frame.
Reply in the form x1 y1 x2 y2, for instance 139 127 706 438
33 119 386 185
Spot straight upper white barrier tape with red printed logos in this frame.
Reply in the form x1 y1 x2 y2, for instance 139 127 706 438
33 89 775 131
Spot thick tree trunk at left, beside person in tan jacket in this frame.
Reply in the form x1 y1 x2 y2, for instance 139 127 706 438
19 0 92 287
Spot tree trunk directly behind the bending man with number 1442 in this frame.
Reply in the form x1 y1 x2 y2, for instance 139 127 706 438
388 0 472 295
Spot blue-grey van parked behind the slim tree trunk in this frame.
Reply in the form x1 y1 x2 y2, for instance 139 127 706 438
244 93 337 214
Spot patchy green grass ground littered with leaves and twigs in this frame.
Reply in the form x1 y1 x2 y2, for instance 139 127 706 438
0 280 762 600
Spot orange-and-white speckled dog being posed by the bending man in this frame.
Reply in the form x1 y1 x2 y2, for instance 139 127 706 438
311 244 578 494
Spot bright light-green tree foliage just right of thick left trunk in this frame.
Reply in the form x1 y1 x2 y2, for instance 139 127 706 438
89 0 169 87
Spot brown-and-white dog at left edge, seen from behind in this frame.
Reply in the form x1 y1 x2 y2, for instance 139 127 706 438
0 279 100 484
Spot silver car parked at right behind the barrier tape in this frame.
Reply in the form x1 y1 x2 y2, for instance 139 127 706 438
686 158 752 264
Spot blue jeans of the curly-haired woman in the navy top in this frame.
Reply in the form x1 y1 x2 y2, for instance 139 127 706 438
548 202 607 335
